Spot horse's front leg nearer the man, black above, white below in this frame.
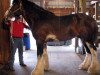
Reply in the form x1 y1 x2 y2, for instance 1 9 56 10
31 42 44 75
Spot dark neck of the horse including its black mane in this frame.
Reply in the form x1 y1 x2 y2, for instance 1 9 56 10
23 2 54 28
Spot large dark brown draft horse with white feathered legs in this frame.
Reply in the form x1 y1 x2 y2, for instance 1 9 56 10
5 0 98 75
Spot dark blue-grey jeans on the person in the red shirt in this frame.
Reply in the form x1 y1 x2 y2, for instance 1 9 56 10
9 38 24 67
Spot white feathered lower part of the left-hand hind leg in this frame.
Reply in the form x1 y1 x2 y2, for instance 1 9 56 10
79 53 91 70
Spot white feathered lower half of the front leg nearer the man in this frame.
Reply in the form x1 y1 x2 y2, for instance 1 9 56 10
31 56 44 75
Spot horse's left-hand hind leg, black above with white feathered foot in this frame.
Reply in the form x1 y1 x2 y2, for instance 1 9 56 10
79 42 91 70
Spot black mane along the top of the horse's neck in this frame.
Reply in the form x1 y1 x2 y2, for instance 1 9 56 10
23 1 54 19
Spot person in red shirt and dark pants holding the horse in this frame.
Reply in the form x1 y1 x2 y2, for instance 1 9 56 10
5 15 30 71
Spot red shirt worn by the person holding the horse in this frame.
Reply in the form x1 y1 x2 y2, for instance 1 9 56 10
11 21 25 38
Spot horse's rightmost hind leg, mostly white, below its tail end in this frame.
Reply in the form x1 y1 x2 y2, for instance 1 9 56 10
86 42 98 73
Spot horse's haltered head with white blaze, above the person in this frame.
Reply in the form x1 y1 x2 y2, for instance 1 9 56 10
5 0 23 19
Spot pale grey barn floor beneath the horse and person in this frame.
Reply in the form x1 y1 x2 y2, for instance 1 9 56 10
0 46 100 75
